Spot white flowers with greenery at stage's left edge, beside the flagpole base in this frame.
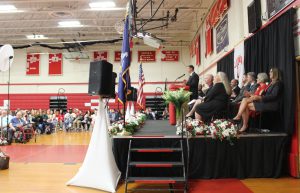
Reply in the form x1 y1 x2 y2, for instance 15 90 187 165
108 113 146 136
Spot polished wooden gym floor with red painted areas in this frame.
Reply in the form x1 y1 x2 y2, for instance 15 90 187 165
0 132 300 193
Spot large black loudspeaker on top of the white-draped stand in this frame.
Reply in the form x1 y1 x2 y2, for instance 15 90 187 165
88 60 116 98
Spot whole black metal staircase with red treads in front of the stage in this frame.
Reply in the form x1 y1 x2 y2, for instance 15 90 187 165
125 138 188 193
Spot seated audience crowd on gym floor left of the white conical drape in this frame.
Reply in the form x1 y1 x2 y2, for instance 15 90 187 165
0 109 95 143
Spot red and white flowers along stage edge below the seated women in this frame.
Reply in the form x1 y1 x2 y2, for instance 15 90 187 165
176 118 238 144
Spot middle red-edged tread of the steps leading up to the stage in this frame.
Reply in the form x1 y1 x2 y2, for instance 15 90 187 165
129 162 183 168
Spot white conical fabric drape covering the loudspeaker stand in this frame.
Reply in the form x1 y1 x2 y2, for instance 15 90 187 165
67 100 121 192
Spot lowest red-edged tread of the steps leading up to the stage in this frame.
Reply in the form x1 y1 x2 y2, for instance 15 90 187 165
127 177 185 184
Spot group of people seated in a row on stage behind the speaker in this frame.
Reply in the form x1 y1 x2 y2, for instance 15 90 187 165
187 68 282 132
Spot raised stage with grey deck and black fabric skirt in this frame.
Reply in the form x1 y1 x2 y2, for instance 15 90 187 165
113 120 289 179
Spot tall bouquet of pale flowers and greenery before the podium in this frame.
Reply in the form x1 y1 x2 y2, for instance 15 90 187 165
162 88 192 118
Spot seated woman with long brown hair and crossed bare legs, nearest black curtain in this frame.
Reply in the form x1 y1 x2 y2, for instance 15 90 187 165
233 68 282 132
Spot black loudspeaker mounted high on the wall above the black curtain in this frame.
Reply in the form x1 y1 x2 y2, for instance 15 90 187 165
248 0 261 33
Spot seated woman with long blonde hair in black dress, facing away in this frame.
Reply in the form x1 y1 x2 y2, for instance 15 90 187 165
195 72 231 121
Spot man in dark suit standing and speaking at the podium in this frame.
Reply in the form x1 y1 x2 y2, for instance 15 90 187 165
184 65 199 100
